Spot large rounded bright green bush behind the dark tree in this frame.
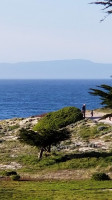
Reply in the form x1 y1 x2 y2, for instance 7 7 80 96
34 107 83 133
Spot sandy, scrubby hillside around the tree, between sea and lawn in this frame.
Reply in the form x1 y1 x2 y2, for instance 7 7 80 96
0 112 112 179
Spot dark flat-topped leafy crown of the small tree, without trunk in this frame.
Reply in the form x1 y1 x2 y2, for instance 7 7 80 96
19 128 70 150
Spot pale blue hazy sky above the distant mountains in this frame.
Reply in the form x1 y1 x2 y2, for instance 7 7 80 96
0 0 112 63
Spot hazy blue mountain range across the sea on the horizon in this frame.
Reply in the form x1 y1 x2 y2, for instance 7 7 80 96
0 59 112 79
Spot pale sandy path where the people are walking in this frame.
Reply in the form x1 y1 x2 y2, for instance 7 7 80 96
86 111 112 124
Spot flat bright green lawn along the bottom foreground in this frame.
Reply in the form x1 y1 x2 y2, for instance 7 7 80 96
0 181 112 200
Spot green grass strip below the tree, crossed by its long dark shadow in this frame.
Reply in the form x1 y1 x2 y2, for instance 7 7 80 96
10 152 112 173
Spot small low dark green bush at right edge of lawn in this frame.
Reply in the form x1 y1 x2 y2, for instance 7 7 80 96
92 173 110 181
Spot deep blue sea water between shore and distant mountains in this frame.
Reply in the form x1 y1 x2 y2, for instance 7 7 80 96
0 79 112 119
